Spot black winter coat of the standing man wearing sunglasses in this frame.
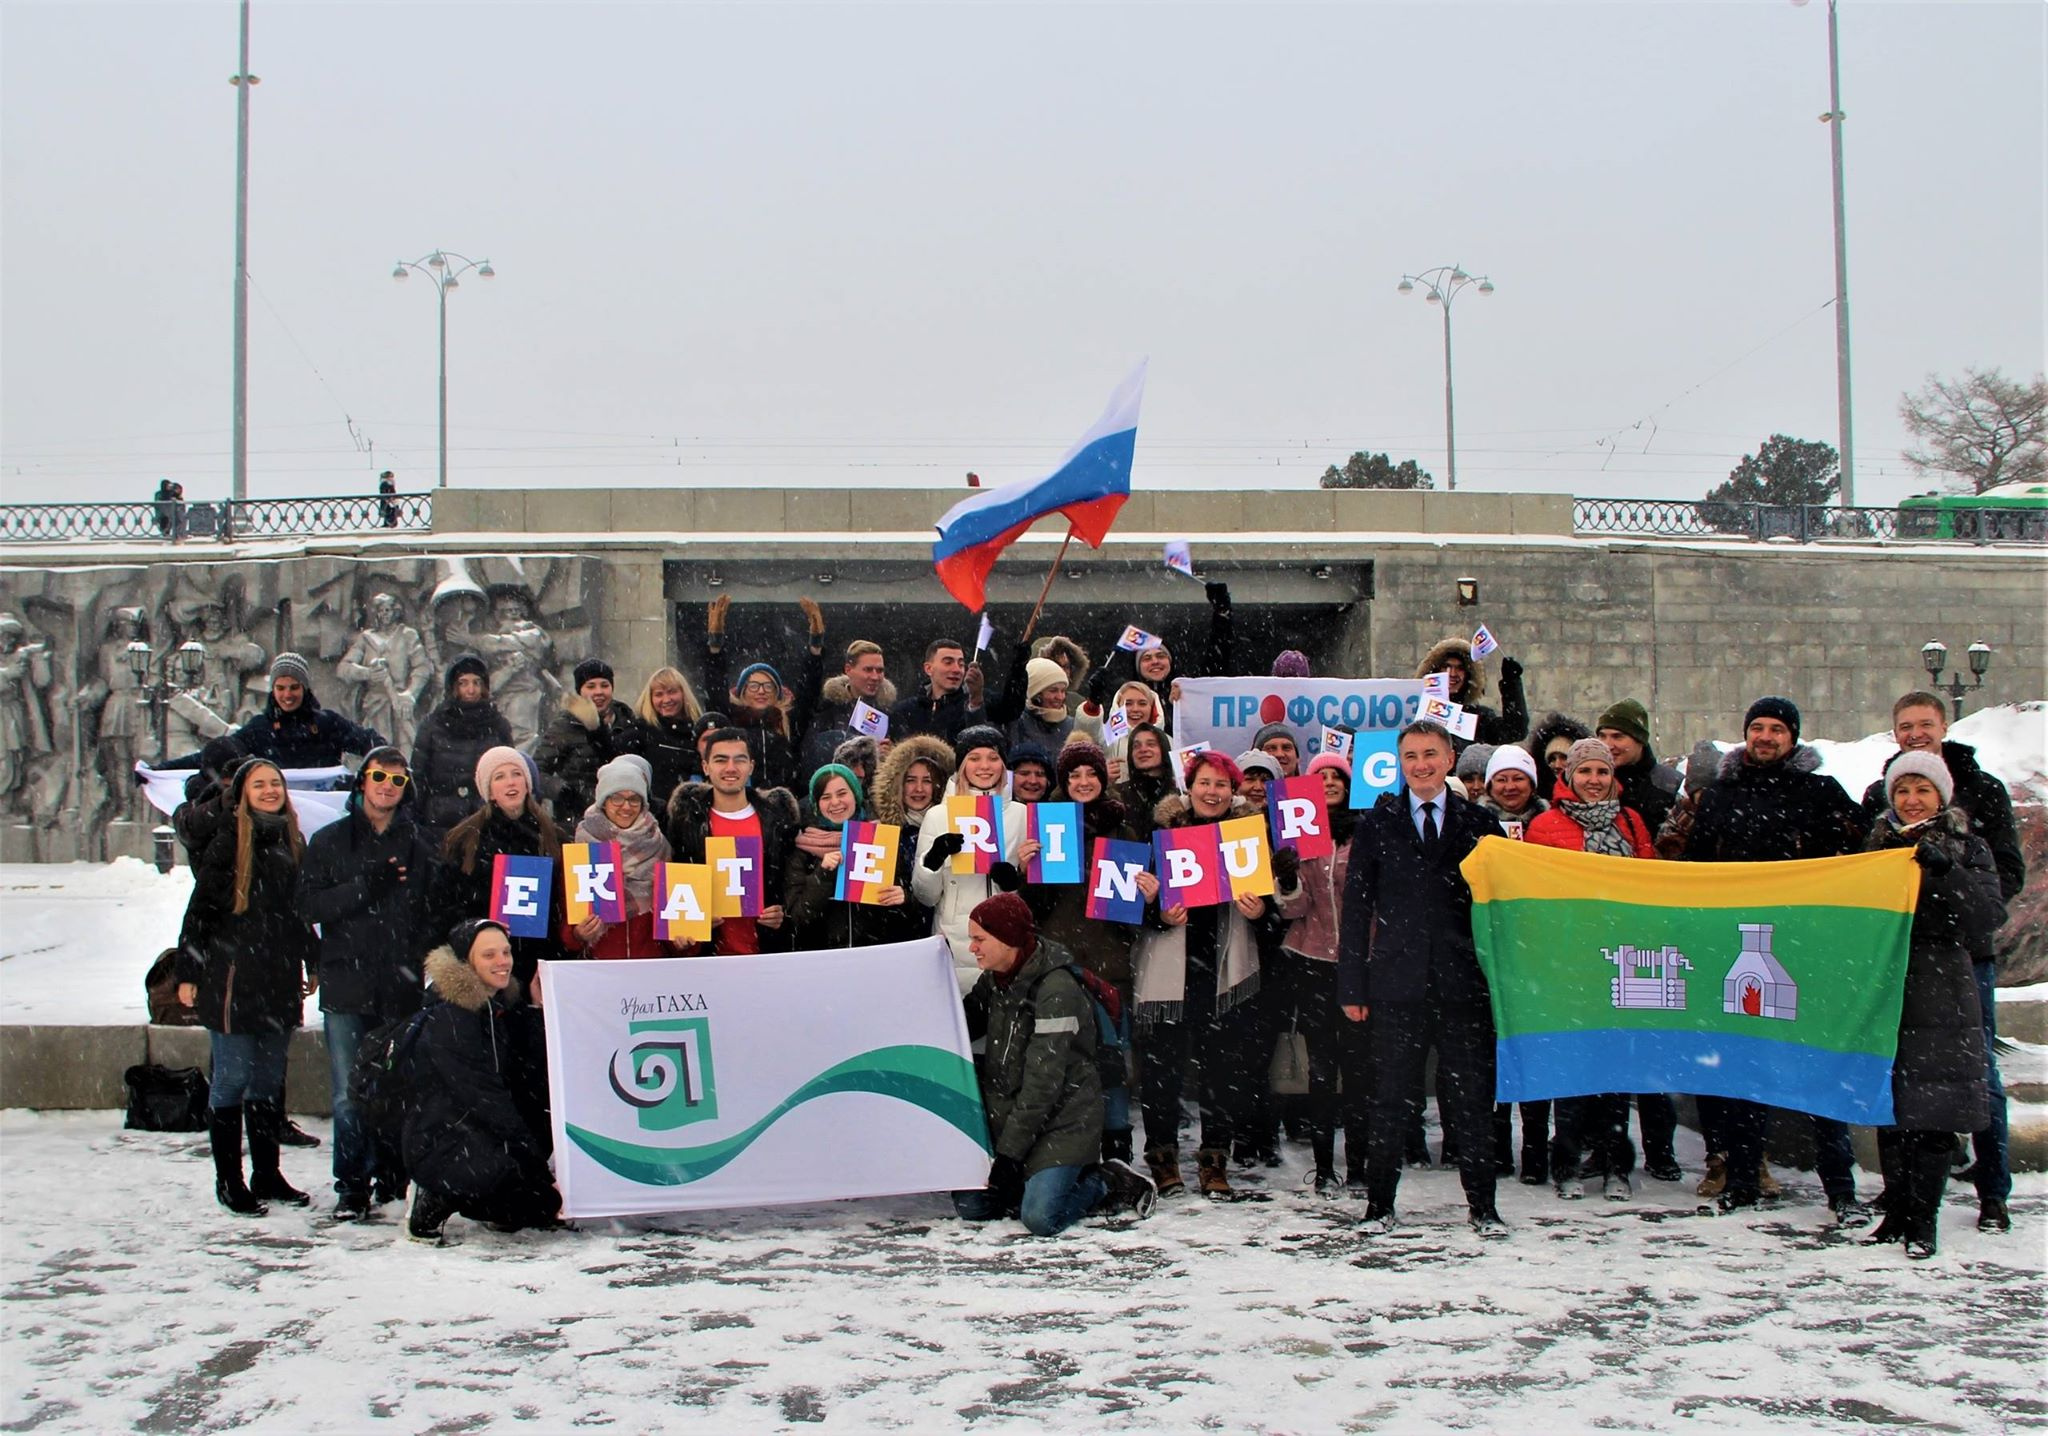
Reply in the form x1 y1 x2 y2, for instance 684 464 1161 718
299 797 440 1022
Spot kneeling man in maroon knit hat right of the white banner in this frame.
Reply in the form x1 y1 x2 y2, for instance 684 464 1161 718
952 893 1157 1237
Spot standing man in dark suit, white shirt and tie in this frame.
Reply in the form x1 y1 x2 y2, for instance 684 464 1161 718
1337 723 1507 1237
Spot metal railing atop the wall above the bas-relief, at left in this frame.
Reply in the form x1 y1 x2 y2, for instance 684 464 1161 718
0 494 434 543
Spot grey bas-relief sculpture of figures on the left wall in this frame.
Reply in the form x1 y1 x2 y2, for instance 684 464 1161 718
0 557 590 862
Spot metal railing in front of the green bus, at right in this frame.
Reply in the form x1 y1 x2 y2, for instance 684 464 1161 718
1571 498 2048 543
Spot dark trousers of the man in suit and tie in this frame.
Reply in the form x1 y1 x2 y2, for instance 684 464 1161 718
1366 994 1495 1211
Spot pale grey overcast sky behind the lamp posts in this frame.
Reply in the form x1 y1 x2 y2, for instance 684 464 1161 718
0 0 2048 502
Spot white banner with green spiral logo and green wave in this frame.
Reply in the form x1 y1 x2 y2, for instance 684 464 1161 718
541 938 989 1217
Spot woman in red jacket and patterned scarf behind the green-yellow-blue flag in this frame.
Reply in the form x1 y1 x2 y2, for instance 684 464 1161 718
1526 737 1657 1202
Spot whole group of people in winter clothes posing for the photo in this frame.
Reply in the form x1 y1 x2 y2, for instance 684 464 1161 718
159 584 2023 1256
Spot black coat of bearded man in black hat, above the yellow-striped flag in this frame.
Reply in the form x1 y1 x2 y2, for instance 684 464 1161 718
1686 746 1870 862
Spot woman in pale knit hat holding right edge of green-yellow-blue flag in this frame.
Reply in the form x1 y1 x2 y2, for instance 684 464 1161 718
1866 750 2005 1260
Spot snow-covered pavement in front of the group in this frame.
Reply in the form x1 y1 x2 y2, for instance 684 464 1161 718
0 1112 2048 1432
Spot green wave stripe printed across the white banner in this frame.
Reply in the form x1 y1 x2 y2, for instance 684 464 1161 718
565 1047 989 1186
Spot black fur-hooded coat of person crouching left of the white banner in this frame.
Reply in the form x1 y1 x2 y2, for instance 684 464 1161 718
403 946 553 1202
